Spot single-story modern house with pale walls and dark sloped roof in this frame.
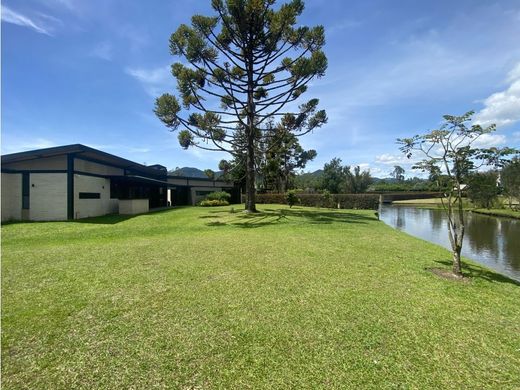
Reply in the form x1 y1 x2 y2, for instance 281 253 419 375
1 144 240 221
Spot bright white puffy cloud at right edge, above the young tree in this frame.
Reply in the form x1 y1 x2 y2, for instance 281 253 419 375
475 63 520 127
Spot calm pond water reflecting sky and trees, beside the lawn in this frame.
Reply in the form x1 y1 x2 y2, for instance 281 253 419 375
379 205 520 281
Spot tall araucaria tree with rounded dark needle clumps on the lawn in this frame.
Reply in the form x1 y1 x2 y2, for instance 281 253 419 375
155 0 327 212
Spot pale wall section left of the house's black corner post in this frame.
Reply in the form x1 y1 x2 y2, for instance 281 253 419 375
29 172 67 221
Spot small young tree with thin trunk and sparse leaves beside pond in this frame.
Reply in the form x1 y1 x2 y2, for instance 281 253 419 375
397 111 517 277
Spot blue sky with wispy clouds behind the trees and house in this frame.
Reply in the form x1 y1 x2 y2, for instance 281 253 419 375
1 0 520 177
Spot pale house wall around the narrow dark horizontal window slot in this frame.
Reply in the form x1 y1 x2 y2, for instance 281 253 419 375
74 174 118 219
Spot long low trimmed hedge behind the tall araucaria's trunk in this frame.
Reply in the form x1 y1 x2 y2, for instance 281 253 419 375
246 194 379 210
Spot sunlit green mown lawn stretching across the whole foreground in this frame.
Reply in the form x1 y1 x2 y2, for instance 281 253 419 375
2 205 520 389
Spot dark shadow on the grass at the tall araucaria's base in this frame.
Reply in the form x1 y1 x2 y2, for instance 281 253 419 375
200 209 377 229
